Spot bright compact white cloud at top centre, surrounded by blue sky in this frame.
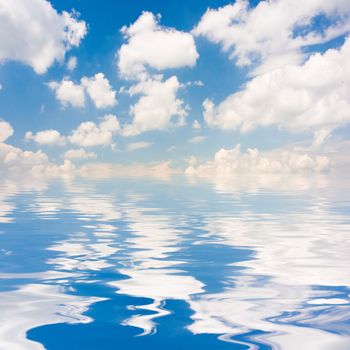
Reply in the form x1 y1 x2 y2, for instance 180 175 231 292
118 12 198 78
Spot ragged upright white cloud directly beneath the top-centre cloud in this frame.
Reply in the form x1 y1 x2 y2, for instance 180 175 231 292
123 76 187 136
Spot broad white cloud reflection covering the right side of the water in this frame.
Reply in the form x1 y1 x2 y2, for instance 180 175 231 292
188 198 350 350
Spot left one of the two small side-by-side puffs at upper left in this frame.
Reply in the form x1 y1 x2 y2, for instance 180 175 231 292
48 79 85 107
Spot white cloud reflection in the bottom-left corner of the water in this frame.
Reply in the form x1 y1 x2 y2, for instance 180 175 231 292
0 284 104 350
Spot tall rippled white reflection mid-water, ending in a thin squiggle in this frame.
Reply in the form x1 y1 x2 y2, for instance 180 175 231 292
110 208 204 335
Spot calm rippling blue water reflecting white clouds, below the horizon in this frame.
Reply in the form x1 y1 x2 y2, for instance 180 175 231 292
0 177 350 350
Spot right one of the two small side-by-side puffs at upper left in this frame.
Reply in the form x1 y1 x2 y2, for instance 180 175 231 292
81 73 117 108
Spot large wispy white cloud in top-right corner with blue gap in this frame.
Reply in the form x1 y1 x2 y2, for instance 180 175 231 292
193 0 350 72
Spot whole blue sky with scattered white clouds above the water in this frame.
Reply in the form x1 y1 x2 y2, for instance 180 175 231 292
0 0 350 176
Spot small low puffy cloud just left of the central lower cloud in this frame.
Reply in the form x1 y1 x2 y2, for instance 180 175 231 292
68 114 120 147
